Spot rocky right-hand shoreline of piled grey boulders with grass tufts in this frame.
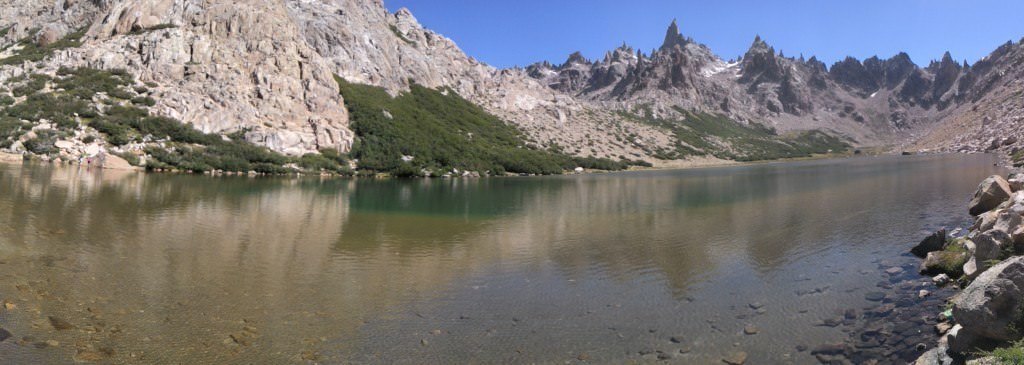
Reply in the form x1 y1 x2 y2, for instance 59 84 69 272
911 172 1024 365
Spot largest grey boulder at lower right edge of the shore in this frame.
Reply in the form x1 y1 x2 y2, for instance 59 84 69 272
949 256 1024 342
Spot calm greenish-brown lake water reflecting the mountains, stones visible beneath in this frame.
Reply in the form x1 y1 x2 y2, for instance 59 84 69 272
0 155 998 364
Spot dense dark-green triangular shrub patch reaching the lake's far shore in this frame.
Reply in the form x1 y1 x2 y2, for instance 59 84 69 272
337 78 631 175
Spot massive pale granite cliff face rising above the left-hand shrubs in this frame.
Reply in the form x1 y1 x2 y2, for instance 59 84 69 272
0 0 352 154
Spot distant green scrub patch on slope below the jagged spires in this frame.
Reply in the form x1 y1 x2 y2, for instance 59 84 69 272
620 108 850 161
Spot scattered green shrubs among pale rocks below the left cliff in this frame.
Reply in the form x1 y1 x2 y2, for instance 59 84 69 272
0 68 350 174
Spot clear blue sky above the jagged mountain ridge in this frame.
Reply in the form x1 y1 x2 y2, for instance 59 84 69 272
384 0 1024 68
